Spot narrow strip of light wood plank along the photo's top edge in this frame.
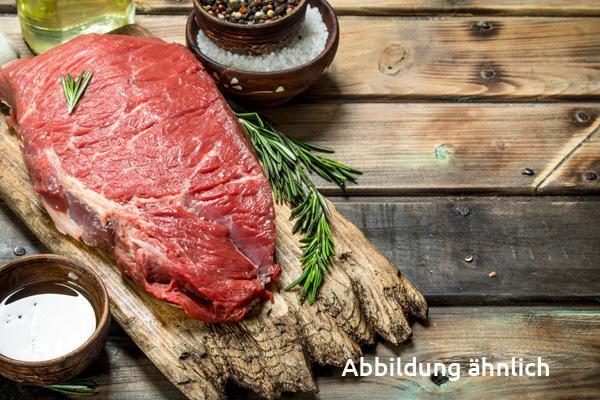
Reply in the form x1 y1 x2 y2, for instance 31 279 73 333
0 0 600 16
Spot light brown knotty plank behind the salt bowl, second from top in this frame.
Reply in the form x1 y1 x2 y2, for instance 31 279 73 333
0 15 600 101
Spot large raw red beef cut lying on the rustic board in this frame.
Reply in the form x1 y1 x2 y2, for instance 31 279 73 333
0 35 280 322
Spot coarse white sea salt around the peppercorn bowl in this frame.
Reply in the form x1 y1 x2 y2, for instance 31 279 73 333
197 6 329 72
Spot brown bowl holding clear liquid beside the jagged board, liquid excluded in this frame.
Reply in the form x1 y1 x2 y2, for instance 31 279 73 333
0 254 110 385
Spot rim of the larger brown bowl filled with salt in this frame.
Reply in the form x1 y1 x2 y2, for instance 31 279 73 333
185 0 340 78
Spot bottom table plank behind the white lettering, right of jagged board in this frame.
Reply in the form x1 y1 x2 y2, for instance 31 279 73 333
264 307 600 400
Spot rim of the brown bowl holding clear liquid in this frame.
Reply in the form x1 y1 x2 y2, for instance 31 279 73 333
0 254 110 368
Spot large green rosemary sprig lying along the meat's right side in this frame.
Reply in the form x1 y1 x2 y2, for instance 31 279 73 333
232 104 361 304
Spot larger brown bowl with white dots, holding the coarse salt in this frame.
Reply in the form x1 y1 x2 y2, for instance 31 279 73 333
186 0 339 107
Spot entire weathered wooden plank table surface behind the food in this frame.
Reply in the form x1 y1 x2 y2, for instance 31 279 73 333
0 0 600 400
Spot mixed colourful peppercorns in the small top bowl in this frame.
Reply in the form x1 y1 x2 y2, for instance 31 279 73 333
200 0 300 25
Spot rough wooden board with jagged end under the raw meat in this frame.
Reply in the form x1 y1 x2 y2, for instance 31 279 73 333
0 26 427 399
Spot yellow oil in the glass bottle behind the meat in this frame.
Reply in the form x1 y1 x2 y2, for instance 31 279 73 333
17 0 135 54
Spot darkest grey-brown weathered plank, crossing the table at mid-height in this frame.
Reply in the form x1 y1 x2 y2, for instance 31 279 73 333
0 197 600 305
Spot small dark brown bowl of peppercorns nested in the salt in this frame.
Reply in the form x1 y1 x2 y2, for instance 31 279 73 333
194 0 306 55
